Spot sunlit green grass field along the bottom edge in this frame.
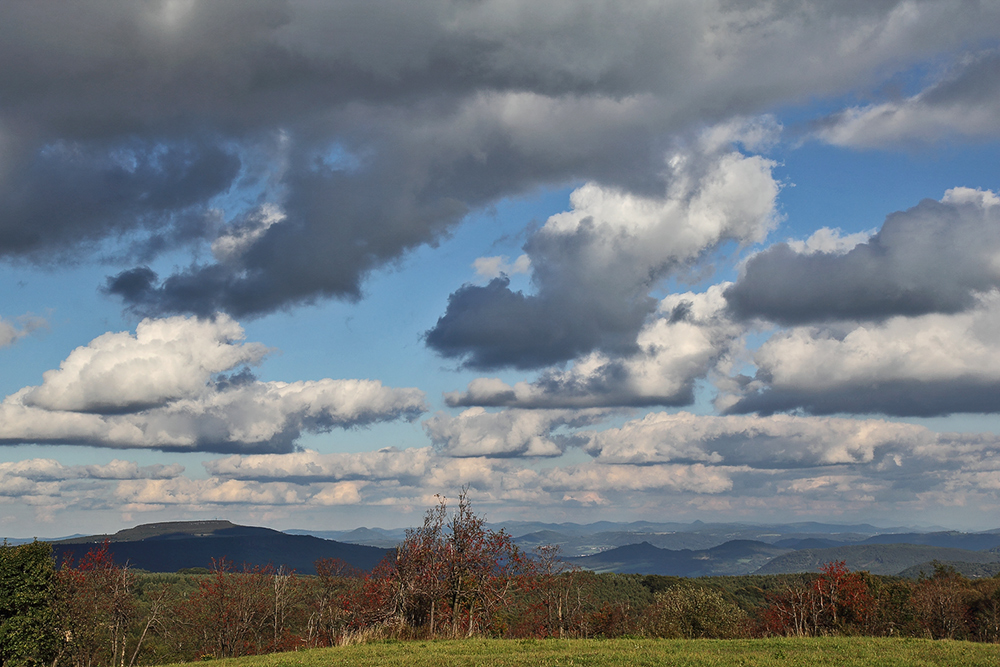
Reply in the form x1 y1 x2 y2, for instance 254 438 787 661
158 637 1000 667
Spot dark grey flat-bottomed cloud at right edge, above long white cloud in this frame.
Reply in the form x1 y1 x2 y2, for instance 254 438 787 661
726 188 1000 325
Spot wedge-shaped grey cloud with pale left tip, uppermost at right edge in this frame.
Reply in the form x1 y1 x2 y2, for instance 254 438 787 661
815 51 1000 148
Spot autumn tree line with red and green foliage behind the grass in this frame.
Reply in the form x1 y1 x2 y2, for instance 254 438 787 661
0 493 1000 667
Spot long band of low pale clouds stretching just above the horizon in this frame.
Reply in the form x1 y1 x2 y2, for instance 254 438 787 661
7 412 1000 520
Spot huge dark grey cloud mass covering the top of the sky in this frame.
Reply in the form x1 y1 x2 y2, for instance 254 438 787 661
0 0 998 315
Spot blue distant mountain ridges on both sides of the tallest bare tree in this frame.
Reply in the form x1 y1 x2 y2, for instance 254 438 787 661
21 520 1000 577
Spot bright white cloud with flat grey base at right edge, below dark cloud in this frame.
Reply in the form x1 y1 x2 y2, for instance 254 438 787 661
720 288 1000 416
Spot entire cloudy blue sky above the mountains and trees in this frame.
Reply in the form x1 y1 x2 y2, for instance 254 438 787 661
0 0 1000 537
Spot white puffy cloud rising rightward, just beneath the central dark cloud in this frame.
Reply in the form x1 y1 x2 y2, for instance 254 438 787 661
445 283 744 408
